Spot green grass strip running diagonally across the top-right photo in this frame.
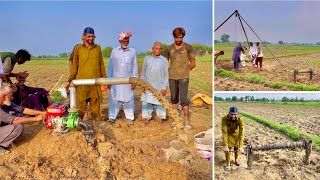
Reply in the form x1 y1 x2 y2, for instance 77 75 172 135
214 68 320 91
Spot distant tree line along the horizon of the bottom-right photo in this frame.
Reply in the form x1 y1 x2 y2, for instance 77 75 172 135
214 96 320 102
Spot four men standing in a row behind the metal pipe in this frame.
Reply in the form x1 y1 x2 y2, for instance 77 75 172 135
66 27 196 129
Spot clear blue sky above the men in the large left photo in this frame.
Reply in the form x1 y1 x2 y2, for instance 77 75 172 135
0 1 212 56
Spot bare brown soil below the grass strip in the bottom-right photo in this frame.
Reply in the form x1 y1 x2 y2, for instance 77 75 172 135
214 103 320 180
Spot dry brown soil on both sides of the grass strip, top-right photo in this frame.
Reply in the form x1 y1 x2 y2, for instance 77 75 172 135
215 54 320 91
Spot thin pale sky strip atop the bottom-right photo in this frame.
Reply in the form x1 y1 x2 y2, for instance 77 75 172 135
215 91 320 100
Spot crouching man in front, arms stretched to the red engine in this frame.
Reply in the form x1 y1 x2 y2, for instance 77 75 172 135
0 86 47 155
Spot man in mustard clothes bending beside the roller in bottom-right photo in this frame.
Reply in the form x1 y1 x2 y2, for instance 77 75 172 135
222 106 244 171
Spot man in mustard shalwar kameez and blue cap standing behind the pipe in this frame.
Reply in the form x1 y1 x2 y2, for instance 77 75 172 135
66 27 106 127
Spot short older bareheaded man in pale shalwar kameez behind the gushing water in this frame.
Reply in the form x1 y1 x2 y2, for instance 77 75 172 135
141 42 169 125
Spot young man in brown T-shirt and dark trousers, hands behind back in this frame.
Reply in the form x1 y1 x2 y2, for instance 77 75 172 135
164 27 196 130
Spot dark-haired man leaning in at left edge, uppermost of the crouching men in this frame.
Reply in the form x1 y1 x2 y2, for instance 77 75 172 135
0 49 31 86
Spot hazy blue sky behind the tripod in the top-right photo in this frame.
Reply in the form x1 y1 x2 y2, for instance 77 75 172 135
214 1 320 43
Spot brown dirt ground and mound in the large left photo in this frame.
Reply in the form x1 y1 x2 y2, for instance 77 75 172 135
0 61 212 179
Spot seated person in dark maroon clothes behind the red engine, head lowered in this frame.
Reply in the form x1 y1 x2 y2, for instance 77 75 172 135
12 76 52 111
